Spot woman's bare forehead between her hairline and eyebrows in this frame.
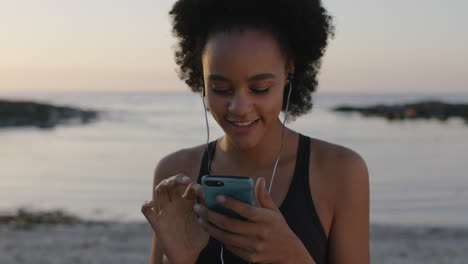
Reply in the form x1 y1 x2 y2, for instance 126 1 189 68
202 29 286 73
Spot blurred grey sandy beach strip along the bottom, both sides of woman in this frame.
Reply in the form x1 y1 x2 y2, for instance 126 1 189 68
0 222 468 264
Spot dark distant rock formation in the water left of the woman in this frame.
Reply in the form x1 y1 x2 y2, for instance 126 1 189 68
0 100 98 128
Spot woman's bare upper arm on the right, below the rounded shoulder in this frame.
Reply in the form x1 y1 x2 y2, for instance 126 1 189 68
330 150 370 264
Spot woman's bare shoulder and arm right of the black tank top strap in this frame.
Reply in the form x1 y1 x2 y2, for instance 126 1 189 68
311 140 369 263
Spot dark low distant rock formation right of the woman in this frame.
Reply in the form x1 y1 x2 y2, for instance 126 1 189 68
333 101 468 124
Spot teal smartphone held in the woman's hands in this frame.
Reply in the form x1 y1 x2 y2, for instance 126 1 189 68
201 175 255 220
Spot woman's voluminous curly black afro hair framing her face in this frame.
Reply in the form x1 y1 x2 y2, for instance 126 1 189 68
169 0 334 118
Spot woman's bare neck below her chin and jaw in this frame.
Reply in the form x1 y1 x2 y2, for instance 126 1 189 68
220 119 294 171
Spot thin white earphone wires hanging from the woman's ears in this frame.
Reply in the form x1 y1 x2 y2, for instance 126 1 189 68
201 73 294 264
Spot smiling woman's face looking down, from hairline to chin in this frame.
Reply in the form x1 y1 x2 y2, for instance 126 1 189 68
202 29 287 149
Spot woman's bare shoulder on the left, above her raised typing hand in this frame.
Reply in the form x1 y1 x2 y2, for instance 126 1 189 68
153 144 206 187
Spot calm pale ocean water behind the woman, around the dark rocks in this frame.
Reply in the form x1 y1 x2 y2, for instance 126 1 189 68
0 91 468 227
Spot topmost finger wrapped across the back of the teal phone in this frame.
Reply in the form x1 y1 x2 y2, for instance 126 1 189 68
216 195 268 222
